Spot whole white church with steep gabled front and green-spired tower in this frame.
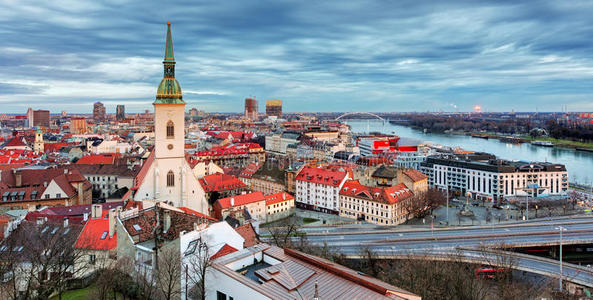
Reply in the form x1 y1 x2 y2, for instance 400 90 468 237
128 23 208 214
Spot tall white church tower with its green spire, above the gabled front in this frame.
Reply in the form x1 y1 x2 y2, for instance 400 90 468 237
153 22 185 159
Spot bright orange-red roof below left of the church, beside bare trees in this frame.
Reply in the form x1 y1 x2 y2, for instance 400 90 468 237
74 212 117 250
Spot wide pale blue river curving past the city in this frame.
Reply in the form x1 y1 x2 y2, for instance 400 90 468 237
345 120 593 185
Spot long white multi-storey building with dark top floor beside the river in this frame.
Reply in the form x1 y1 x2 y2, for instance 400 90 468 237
420 152 568 202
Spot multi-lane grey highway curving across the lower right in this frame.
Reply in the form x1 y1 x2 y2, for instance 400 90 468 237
268 217 593 287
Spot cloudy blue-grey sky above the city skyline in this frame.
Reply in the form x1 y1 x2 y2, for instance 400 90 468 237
0 0 593 113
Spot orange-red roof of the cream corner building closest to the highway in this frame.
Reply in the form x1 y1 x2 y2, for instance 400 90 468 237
340 180 414 204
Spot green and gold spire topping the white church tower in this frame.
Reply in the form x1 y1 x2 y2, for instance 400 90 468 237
153 22 185 104
